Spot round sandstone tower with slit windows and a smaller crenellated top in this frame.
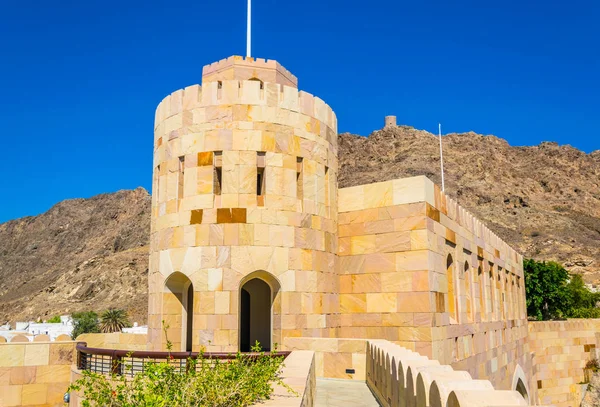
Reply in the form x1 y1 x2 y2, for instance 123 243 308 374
148 57 339 351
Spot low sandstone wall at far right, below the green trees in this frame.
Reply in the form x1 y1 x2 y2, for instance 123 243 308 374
528 319 600 407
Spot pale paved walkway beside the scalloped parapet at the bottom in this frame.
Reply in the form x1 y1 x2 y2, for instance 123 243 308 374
315 379 380 407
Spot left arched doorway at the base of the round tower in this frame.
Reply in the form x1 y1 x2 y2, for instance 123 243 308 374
162 272 194 351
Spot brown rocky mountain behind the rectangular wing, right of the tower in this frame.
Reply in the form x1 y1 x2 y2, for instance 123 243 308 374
339 126 600 283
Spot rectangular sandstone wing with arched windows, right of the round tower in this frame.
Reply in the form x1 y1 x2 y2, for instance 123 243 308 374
338 177 532 398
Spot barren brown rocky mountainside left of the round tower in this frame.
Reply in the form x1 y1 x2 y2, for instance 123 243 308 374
0 188 150 323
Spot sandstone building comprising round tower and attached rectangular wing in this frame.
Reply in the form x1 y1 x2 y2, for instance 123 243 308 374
148 52 531 396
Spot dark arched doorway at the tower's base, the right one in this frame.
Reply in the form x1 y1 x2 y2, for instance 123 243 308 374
240 278 273 352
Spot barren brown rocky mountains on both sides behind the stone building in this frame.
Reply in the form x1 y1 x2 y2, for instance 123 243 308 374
0 126 600 323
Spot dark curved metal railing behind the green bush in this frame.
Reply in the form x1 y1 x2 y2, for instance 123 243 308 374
76 342 291 376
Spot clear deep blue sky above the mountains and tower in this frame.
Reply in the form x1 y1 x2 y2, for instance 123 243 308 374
0 0 600 222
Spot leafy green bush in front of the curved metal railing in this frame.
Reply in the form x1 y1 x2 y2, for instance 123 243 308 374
68 345 293 407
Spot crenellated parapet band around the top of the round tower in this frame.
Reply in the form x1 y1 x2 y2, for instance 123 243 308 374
155 79 337 134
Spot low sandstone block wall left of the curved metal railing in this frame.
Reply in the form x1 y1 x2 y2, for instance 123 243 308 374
0 341 77 407
